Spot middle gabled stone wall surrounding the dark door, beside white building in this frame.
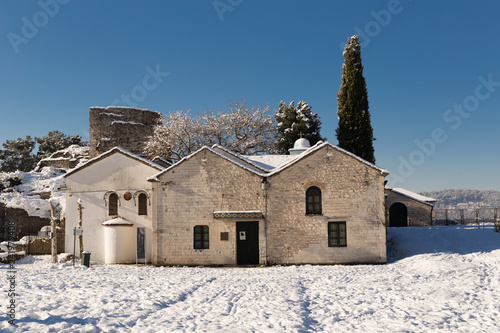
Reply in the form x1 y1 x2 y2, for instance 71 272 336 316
153 150 265 265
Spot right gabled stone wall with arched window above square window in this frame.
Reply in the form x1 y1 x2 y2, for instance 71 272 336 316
268 146 386 264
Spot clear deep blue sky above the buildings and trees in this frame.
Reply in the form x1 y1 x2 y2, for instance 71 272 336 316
0 0 500 191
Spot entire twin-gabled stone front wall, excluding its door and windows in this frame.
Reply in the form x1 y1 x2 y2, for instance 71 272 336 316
153 147 386 265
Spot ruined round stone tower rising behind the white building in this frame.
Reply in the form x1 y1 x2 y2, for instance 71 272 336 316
89 106 161 158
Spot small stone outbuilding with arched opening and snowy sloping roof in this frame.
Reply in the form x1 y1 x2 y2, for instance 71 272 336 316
385 187 436 227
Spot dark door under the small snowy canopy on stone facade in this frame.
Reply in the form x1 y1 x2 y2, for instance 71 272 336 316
236 222 259 265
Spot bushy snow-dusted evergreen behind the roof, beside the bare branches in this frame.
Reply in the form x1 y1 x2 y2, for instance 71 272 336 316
276 101 326 154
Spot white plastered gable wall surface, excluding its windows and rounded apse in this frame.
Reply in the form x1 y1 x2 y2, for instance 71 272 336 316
66 152 159 263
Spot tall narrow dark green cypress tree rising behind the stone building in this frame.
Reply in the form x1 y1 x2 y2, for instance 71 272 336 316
336 36 375 163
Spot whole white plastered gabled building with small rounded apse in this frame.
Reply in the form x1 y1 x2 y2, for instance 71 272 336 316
65 148 164 264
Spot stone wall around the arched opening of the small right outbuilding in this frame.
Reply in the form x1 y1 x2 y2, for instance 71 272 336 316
385 190 435 227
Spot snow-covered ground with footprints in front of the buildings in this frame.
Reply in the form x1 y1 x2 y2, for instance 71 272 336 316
0 226 500 332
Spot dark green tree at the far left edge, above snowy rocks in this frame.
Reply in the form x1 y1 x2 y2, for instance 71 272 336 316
0 135 38 172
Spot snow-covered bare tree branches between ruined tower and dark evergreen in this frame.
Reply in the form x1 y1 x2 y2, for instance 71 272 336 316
144 101 276 160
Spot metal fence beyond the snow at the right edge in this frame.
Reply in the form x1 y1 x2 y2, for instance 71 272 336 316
434 207 500 225
